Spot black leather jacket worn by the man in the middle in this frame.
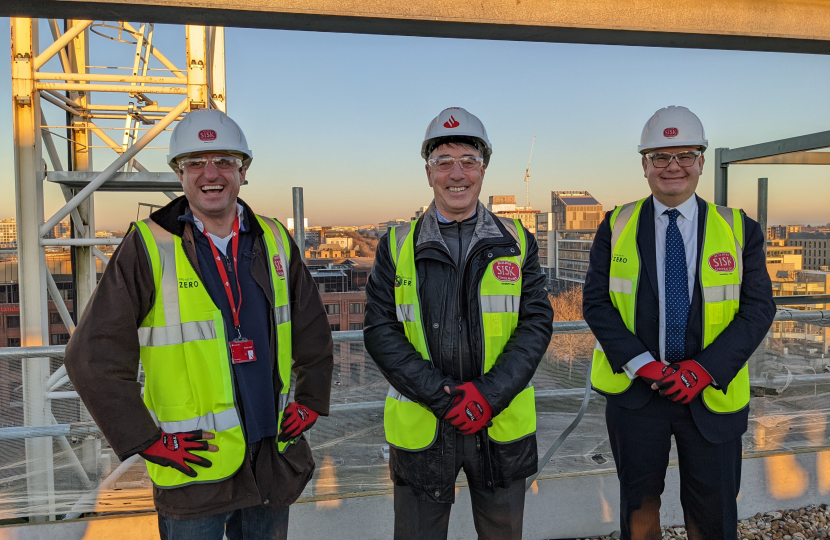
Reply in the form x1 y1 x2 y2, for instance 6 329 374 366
364 204 553 502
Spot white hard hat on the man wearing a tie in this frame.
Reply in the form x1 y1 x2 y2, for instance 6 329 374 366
639 105 709 154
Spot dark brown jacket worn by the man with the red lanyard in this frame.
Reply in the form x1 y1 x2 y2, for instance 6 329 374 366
65 197 333 519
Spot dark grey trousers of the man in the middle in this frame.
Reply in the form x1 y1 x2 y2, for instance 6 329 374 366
395 434 525 540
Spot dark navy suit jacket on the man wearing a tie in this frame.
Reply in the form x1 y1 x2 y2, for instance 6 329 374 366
582 197 775 443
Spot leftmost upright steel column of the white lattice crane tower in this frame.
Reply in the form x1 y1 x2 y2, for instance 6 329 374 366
11 18 55 521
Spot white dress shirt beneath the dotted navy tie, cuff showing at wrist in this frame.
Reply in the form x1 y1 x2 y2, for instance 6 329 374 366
623 195 698 379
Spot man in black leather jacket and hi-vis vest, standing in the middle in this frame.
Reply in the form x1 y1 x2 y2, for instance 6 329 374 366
364 108 553 540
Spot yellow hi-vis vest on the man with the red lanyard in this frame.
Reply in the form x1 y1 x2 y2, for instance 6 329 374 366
135 216 291 488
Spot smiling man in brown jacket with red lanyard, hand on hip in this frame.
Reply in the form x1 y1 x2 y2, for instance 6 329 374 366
66 109 333 540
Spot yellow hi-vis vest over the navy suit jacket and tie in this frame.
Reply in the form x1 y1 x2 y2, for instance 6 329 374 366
591 199 749 413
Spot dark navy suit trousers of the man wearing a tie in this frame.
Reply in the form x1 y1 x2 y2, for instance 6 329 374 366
605 395 741 540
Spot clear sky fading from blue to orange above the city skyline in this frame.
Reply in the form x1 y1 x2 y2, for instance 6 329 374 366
0 19 830 229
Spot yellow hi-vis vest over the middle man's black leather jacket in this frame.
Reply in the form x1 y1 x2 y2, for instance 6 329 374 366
383 220 536 450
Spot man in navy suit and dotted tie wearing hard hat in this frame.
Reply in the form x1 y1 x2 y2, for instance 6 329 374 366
583 107 775 540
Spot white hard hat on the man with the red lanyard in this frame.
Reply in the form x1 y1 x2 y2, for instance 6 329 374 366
167 109 254 170
